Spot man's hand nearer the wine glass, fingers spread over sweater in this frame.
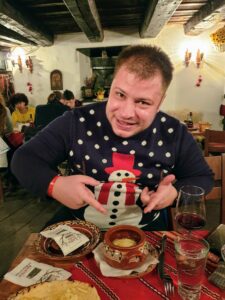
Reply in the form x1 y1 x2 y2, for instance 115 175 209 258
141 174 177 213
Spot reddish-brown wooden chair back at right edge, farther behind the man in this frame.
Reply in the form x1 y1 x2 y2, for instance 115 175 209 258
204 129 225 156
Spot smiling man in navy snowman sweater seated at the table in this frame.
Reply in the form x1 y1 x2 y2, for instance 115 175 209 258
12 45 213 230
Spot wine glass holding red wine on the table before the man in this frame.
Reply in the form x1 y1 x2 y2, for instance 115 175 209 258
175 185 206 234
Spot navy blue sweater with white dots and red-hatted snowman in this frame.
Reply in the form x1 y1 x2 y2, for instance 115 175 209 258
12 103 213 229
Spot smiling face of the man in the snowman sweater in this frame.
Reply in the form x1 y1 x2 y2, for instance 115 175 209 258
106 66 165 138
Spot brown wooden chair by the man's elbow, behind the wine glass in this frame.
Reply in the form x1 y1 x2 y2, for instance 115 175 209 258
169 154 225 230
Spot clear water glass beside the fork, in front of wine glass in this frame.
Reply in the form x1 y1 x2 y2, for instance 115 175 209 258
174 234 209 300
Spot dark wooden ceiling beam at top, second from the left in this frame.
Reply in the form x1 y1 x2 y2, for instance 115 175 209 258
63 0 104 42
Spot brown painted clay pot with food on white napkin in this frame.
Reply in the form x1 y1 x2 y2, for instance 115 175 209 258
103 225 149 270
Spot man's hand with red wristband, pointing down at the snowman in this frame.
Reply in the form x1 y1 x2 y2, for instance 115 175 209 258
52 175 106 213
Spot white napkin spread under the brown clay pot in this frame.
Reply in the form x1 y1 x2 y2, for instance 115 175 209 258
93 243 158 277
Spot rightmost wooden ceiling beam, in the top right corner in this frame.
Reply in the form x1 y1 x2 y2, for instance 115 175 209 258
184 0 225 35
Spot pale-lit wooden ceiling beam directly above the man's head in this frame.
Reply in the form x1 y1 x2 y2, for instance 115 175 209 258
139 0 182 38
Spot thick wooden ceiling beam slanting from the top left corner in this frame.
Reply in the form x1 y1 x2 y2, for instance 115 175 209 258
0 0 53 46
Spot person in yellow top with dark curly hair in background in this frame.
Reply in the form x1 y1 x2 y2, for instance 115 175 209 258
10 93 35 128
